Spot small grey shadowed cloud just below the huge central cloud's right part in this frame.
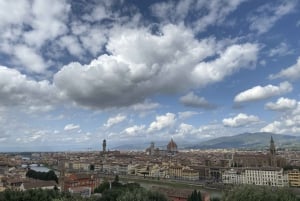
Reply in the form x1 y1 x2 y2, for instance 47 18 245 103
179 92 214 109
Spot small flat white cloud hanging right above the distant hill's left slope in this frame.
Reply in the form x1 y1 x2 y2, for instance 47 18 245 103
223 113 259 127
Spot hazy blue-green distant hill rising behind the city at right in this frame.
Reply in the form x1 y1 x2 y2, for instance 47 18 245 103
188 132 300 149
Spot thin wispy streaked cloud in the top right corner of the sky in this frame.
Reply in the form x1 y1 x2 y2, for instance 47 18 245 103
248 1 297 34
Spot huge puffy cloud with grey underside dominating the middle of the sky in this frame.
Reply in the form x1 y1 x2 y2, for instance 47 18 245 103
54 25 258 108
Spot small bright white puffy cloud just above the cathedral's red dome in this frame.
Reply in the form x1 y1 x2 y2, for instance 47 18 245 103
148 113 176 132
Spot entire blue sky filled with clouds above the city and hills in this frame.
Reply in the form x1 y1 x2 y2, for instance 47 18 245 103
0 0 300 151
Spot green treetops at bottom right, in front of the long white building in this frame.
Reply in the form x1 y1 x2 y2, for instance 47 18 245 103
222 185 298 201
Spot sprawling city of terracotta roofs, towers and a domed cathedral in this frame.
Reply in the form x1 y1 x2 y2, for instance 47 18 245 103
0 136 300 201
